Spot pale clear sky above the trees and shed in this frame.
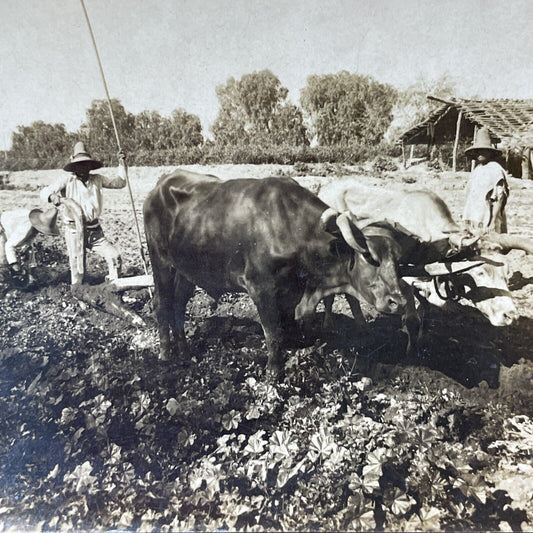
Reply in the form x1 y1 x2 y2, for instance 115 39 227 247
0 0 533 149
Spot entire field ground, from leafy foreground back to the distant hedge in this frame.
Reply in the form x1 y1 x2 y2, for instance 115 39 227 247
0 165 533 532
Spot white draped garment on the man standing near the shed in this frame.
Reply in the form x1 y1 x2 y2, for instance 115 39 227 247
463 161 509 233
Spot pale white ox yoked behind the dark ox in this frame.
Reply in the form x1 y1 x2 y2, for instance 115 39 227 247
319 180 533 351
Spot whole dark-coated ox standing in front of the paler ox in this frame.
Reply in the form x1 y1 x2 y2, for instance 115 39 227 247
144 170 406 375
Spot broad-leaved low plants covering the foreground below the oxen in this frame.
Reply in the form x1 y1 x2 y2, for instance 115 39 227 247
0 228 533 531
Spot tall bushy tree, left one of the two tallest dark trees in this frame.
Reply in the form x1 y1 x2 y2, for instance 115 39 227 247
212 70 307 145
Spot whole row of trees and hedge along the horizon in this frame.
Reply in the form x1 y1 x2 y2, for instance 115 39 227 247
4 70 454 170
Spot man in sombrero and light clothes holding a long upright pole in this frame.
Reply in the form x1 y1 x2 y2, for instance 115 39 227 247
41 142 126 285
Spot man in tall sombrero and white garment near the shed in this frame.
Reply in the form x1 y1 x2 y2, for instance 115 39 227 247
463 128 509 235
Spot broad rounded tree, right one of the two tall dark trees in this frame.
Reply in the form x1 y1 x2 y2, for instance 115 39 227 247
301 71 396 145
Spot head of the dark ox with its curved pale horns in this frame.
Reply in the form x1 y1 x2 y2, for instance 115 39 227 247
321 208 406 314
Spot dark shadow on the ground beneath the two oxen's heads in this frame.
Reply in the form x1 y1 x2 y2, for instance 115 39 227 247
318 308 533 389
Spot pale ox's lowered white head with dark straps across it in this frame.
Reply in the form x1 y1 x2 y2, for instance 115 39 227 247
412 257 518 326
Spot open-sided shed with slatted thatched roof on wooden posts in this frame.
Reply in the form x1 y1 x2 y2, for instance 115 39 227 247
399 96 533 177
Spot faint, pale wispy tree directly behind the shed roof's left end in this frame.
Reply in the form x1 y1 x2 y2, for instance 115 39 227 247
386 74 456 141
